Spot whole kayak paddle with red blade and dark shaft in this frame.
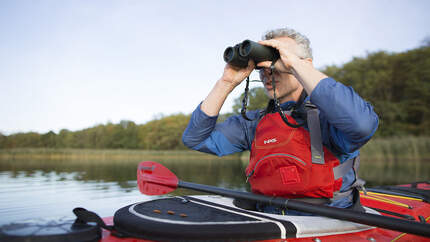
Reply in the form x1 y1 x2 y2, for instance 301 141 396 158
137 161 430 237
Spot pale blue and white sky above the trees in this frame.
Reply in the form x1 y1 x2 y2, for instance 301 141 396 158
0 0 430 135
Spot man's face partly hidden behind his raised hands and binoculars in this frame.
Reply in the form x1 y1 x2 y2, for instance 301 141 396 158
259 37 303 103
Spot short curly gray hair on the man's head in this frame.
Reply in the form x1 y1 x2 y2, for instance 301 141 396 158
262 27 313 59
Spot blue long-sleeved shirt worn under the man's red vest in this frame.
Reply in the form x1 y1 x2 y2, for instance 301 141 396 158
182 78 378 207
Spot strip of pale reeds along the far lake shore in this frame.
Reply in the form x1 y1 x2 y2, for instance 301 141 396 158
0 136 430 163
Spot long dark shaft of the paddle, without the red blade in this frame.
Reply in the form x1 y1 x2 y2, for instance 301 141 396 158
177 181 430 237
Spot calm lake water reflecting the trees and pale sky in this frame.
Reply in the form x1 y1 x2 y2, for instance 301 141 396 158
0 159 430 225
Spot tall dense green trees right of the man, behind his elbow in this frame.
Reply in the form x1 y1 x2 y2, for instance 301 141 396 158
323 46 430 136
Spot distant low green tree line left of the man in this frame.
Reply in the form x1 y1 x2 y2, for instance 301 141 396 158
0 114 190 150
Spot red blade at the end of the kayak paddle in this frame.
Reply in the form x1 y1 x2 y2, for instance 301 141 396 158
137 161 178 195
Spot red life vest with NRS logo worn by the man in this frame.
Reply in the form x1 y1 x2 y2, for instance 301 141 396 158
245 113 342 198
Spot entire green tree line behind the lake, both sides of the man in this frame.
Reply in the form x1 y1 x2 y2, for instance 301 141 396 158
0 42 430 150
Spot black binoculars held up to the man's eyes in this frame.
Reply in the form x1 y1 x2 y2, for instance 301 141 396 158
224 40 279 68
